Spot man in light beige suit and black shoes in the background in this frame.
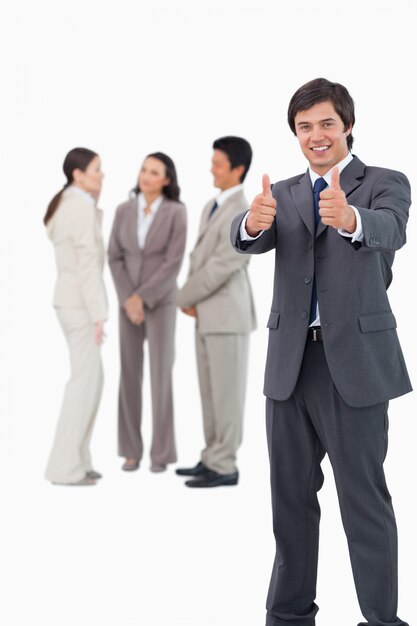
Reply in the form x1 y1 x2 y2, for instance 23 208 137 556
176 137 256 488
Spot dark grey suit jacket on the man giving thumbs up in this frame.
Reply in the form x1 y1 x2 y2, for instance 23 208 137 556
231 157 412 407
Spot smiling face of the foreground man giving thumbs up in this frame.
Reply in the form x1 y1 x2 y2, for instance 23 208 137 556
294 101 352 176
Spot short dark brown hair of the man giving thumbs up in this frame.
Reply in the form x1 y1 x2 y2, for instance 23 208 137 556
288 78 355 150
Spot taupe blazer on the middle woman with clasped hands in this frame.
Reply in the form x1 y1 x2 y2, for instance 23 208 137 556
108 198 187 309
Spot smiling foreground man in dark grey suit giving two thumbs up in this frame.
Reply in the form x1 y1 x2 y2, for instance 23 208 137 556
231 78 411 626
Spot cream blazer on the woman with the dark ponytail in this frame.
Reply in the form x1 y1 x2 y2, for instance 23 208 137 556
47 189 108 322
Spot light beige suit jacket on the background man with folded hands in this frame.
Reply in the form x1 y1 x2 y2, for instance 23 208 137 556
177 190 256 334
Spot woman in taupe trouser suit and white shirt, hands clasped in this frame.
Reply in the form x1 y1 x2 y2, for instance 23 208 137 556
108 152 186 472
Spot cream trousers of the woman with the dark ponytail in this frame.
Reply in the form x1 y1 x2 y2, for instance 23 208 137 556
45 308 103 483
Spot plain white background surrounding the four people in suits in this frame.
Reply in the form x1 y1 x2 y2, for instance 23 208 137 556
0 0 417 626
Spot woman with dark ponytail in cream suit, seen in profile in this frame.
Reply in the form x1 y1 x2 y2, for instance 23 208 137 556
44 148 107 485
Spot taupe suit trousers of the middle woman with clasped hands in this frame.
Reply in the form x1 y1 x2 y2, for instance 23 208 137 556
119 304 177 465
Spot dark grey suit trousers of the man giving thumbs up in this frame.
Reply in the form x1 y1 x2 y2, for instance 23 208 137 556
266 341 407 626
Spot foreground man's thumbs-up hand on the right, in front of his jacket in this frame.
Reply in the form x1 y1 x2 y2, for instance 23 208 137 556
319 167 356 233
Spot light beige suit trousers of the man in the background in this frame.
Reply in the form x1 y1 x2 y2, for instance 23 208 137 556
196 331 249 474
